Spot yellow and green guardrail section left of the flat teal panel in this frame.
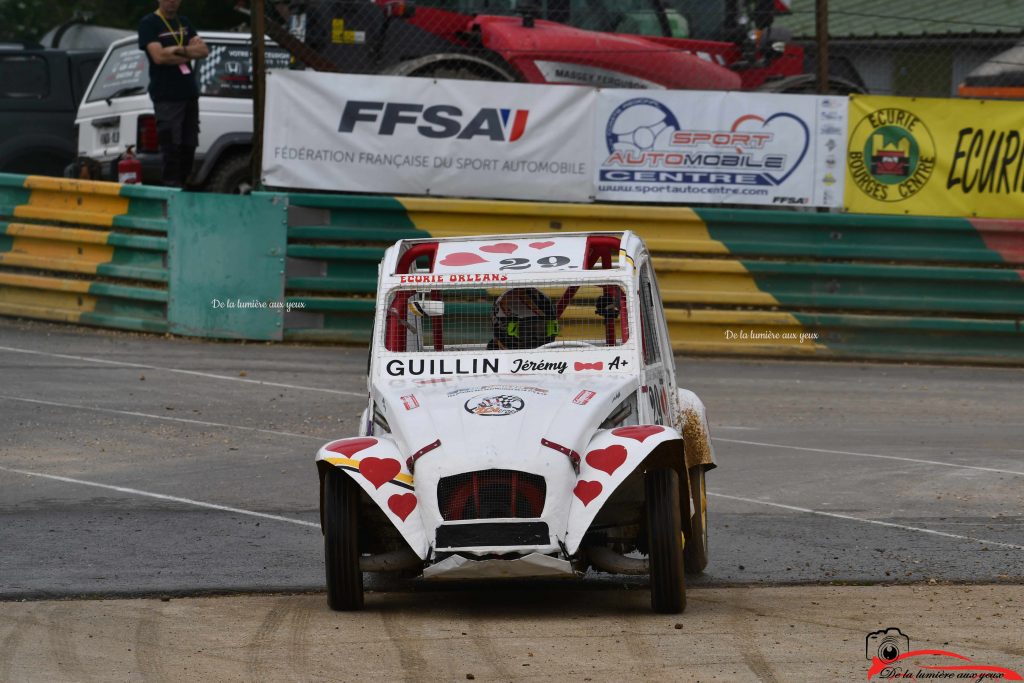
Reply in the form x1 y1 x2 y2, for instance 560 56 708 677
0 174 175 332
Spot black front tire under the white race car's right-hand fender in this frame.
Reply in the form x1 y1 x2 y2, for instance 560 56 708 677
644 469 686 614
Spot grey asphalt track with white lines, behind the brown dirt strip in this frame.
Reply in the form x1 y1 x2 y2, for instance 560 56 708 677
0 319 1024 598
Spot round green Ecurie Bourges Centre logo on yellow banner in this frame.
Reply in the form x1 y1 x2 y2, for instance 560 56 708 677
849 108 935 202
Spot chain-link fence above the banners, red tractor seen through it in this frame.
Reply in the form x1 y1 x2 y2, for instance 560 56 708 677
243 0 1024 97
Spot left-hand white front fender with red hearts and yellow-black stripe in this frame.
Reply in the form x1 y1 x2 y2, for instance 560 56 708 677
316 436 429 559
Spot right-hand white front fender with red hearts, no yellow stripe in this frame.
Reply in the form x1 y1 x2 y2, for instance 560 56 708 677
565 425 692 555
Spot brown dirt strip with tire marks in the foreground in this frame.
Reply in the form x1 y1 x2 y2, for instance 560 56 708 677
0 585 1024 683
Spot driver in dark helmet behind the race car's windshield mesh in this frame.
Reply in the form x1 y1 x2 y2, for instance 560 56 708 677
487 287 558 350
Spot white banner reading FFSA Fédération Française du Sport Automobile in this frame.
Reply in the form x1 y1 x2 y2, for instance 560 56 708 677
263 71 596 202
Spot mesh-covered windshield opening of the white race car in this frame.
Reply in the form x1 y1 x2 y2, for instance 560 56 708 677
384 284 630 352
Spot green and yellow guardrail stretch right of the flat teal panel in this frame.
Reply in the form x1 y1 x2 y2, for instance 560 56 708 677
285 195 1024 364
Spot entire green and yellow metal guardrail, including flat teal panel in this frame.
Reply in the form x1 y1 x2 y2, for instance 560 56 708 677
0 175 1024 365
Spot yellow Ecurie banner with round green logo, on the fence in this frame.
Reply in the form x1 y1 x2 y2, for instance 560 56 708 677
845 95 1024 218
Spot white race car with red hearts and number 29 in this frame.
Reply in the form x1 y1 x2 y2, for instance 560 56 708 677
316 231 715 612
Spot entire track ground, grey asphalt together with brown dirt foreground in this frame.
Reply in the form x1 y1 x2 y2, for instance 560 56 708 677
0 319 1024 682
